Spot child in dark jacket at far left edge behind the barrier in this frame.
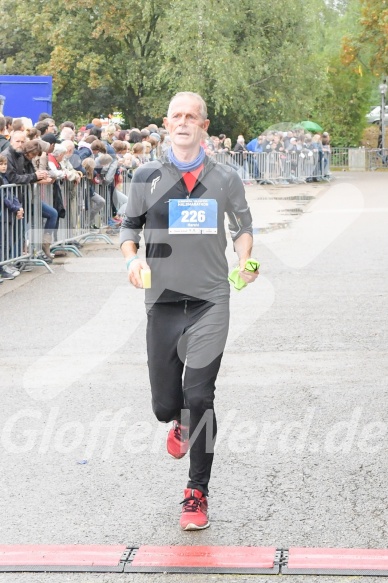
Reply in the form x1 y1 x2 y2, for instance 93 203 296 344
0 154 24 283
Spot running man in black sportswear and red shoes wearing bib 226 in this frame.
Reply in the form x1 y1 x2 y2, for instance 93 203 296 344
120 92 258 530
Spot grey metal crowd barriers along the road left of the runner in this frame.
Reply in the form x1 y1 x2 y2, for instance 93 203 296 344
0 179 113 273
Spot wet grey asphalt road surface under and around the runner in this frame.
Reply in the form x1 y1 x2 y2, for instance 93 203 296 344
0 173 388 583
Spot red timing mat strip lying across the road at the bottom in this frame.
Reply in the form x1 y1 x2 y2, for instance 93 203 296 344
0 545 388 576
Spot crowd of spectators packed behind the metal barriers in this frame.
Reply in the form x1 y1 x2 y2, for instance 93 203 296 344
0 113 330 283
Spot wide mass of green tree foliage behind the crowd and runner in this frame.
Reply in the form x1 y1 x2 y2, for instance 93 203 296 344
0 0 377 143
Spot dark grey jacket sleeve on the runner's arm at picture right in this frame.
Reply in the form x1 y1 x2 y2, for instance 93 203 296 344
226 169 253 241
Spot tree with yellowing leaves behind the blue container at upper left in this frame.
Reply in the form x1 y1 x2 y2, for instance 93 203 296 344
0 0 164 125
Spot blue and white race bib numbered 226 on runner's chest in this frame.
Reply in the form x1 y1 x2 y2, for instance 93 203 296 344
168 198 217 235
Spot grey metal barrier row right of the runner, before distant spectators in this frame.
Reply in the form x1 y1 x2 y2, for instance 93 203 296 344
215 150 330 184
